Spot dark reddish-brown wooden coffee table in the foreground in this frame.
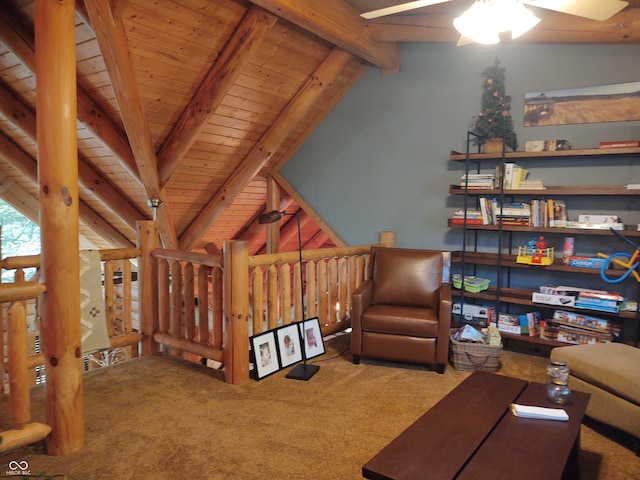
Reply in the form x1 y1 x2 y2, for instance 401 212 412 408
362 371 589 480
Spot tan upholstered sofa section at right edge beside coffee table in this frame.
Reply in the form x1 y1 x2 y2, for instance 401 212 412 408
551 343 640 439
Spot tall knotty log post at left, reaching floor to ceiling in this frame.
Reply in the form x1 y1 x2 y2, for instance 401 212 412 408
35 0 84 455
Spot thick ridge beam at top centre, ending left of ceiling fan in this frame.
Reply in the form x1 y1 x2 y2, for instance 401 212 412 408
250 0 400 72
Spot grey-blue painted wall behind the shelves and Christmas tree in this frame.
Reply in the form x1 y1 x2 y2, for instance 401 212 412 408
281 44 640 249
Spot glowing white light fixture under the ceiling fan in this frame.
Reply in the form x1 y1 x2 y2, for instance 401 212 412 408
453 0 540 45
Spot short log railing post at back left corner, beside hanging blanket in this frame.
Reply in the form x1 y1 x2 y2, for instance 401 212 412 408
136 220 160 355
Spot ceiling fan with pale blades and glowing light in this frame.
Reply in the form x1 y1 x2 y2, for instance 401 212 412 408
361 0 629 45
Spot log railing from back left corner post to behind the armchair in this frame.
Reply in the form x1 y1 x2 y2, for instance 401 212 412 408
149 232 393 384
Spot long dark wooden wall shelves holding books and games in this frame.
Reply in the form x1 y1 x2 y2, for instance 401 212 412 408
448 144 640 346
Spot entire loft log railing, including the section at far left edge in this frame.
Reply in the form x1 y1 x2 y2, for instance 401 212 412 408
0 221 393 453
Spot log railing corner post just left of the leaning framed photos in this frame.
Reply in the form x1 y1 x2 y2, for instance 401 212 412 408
223 240 249 385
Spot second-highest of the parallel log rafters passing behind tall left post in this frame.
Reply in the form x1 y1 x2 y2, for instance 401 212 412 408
0 83 145 237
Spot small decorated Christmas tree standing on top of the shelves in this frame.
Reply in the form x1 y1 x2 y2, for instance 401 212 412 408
473 58 518 150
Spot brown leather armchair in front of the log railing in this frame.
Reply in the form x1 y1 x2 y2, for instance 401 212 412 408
351 247 451 373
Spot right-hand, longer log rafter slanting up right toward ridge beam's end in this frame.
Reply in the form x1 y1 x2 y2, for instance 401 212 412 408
180 49 353 250
